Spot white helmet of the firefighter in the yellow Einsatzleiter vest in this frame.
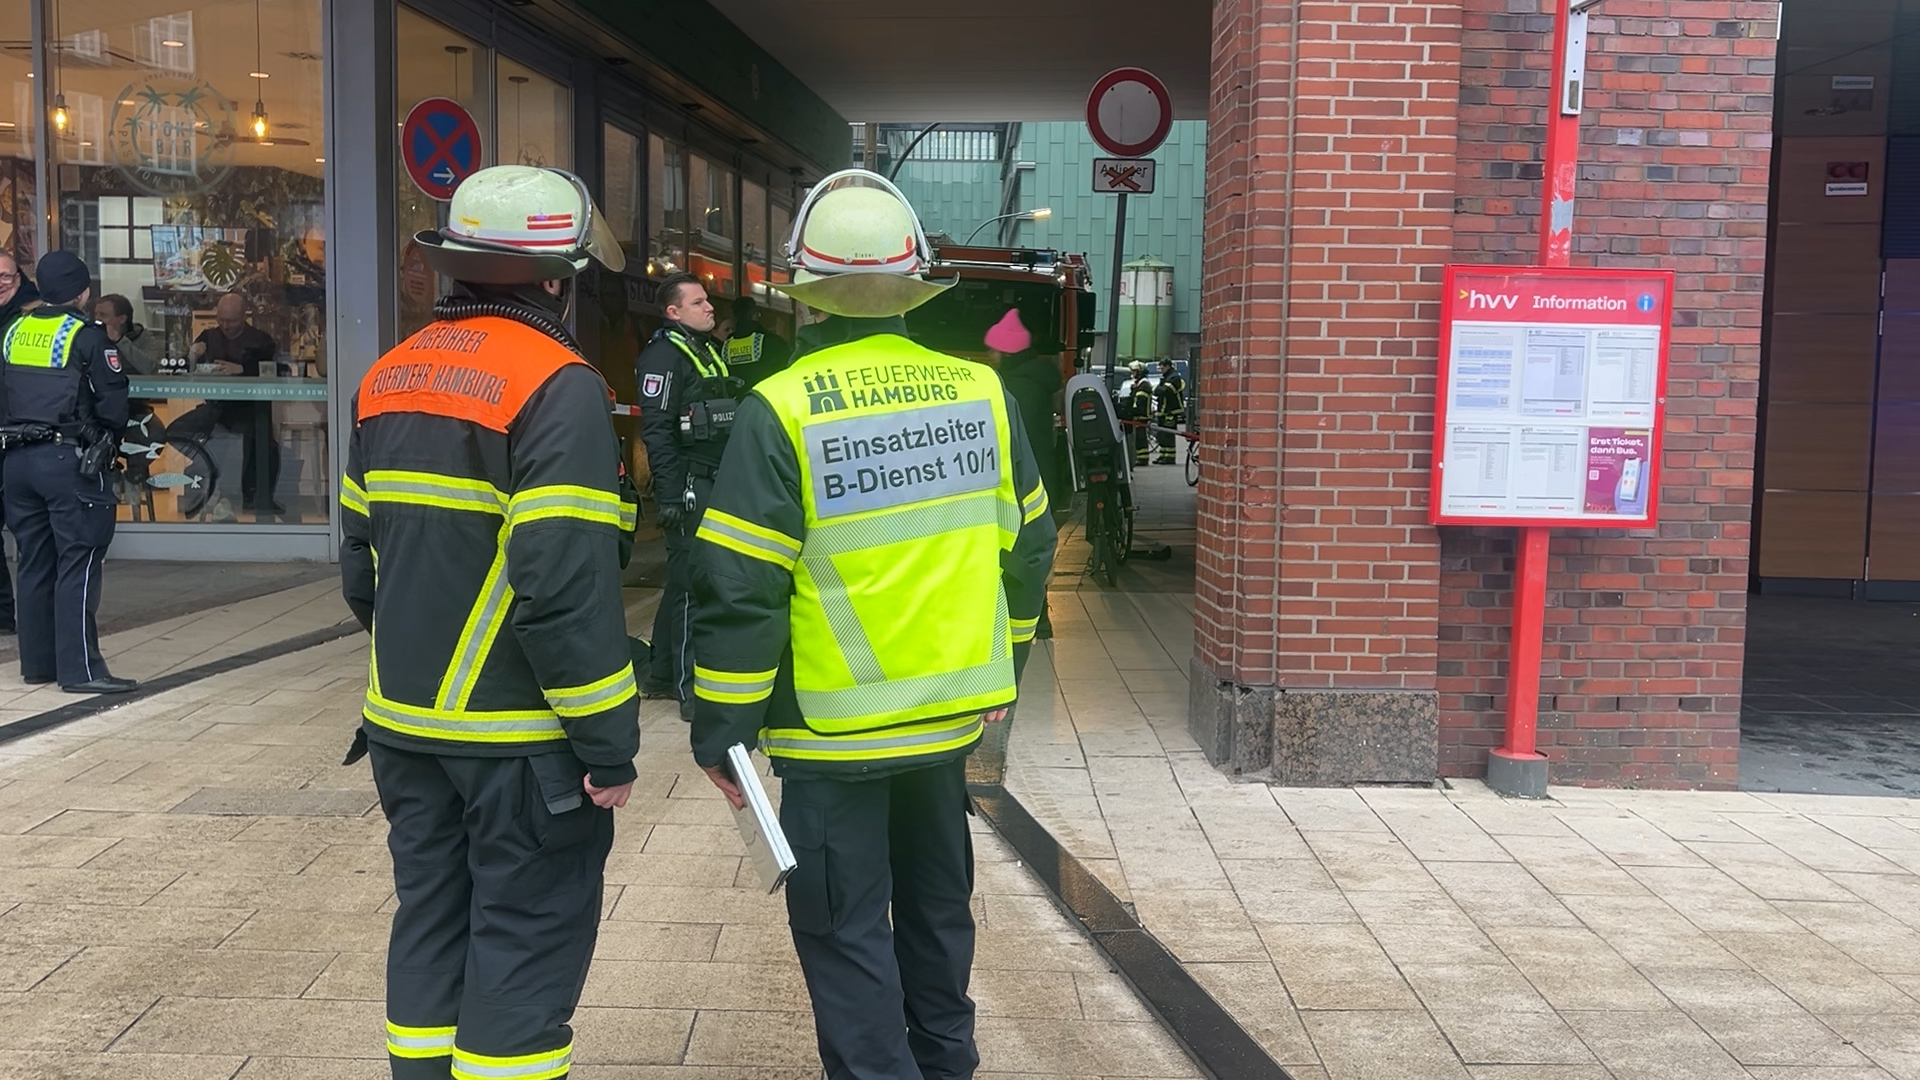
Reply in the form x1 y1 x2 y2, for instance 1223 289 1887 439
774 169 954 319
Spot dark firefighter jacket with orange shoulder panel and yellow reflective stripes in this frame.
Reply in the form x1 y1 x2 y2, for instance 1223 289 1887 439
340 317 639 786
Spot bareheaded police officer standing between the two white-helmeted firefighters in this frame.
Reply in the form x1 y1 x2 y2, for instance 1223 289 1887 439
637 273 745 719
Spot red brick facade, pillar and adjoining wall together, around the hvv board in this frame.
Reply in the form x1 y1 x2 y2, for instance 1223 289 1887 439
1190 0 1774 786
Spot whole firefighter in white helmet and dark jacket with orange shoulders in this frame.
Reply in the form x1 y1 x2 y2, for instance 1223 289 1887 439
340 165 639 1080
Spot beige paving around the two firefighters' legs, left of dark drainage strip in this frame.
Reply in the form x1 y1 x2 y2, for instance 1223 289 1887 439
0 590 1198 1080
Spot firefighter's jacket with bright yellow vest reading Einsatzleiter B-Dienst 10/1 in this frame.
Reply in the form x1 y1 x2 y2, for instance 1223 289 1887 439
693 319 1054 774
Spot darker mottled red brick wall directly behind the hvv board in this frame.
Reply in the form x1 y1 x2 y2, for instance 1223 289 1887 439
1438 0 1780 786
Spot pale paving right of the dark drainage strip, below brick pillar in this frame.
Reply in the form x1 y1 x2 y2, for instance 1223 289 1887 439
1006 580 1920 1080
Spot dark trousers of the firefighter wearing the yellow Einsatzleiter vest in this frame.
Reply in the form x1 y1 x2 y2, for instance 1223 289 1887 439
780 761 979 1080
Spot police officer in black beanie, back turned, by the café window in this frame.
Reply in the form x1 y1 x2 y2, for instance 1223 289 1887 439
0 252 134 694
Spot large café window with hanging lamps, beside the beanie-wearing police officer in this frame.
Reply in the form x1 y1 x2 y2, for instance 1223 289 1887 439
52 0 332 525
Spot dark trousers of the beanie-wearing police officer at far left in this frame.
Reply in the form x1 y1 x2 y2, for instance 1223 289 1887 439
0 442 117 686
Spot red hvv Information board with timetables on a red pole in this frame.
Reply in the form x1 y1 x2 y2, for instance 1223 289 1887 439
1428 265 1674 528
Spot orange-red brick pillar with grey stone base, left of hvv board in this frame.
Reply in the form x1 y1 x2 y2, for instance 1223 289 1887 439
1192 0 1461 784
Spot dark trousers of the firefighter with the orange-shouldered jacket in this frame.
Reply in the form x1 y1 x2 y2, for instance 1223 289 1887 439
369 744 612 1080
